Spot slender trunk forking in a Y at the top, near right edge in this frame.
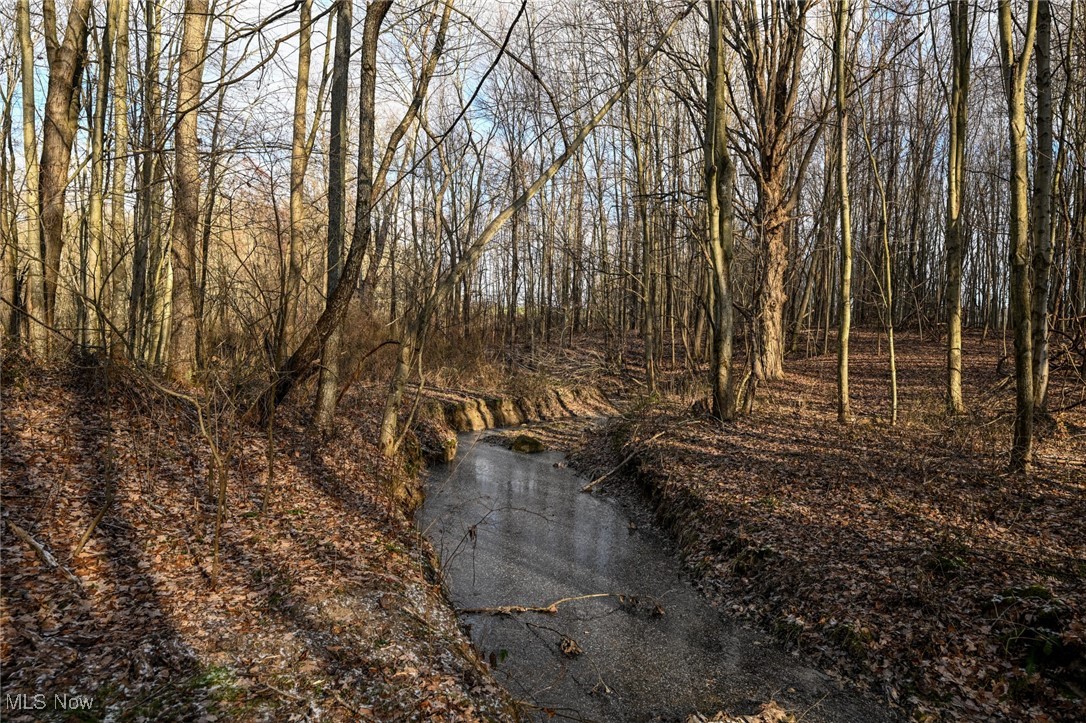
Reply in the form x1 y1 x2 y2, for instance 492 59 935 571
999 0 1038 471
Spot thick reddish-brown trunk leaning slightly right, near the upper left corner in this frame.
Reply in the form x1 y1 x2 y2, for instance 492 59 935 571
38 0 91 345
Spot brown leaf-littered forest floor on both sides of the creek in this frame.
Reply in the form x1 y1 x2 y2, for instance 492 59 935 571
0 332 1086 721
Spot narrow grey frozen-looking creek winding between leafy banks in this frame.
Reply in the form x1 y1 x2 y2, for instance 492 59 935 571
417 433 894 722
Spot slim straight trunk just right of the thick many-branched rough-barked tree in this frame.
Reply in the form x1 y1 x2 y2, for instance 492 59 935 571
833 0 853 423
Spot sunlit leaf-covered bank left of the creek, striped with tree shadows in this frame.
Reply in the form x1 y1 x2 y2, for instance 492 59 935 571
0 357 510 721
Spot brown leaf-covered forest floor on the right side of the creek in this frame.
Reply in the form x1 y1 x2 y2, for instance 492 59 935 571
573 333 1086 721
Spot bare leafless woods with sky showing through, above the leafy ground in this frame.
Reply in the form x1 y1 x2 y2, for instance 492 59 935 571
4 1 1086 467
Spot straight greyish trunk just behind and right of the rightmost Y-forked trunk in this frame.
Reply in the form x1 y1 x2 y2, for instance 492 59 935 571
1030 2 1052 409
